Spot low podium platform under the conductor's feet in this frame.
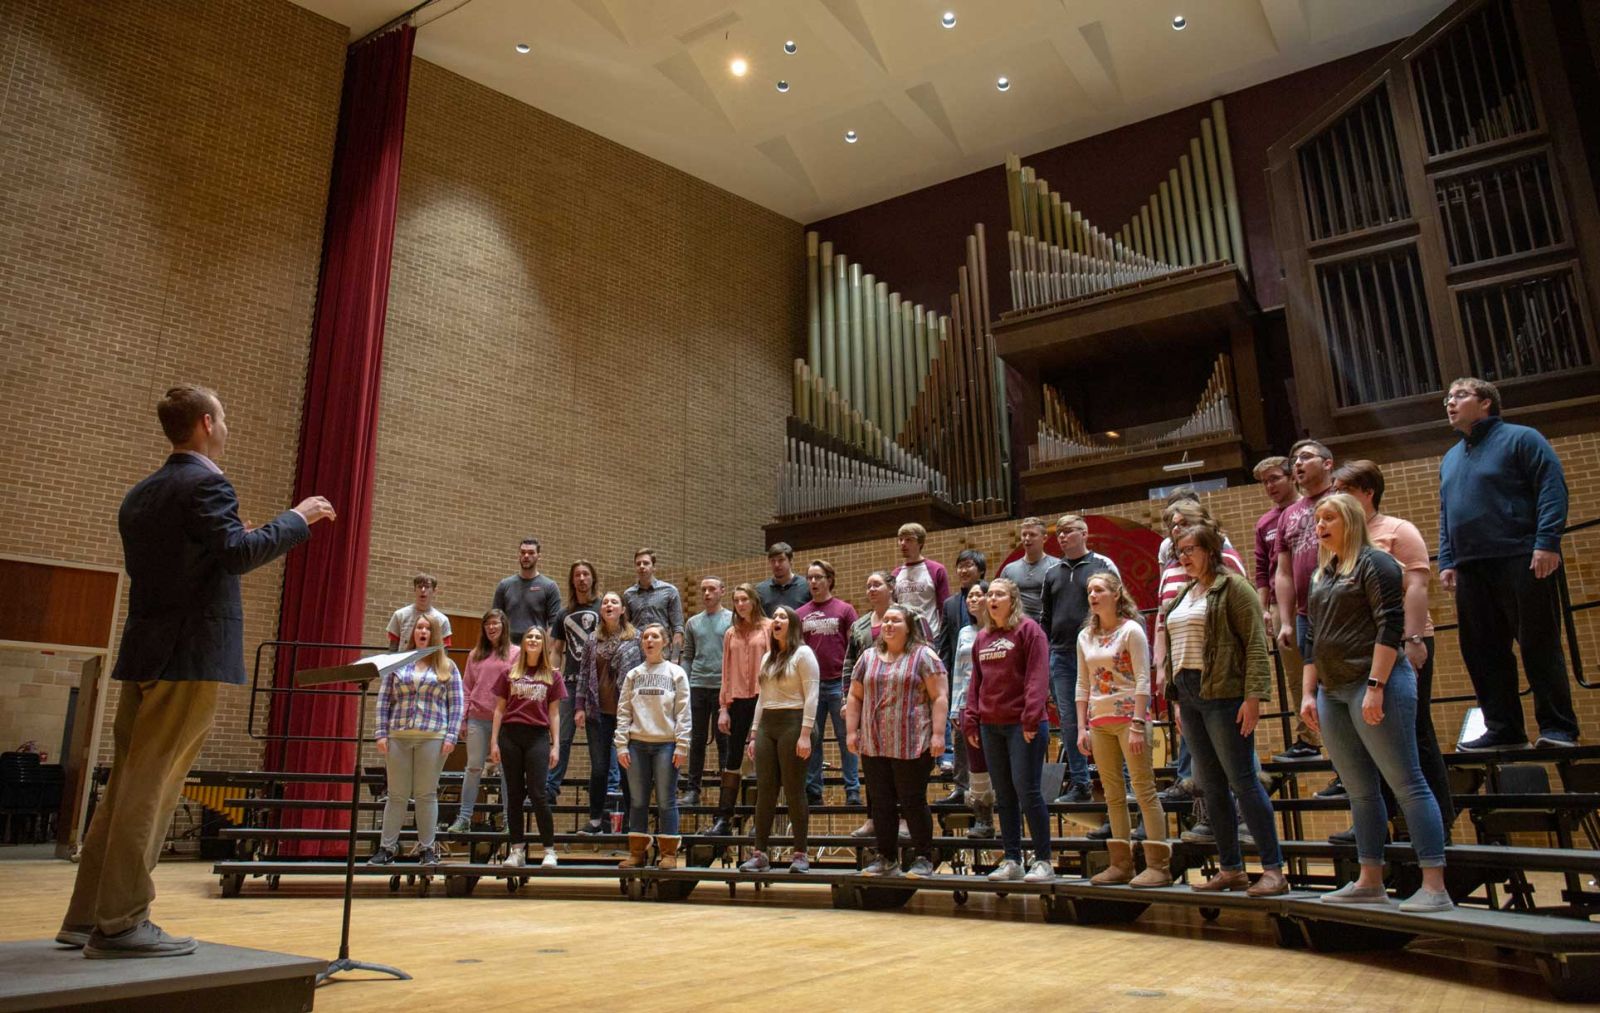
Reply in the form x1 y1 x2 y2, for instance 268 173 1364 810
0 939 328 1013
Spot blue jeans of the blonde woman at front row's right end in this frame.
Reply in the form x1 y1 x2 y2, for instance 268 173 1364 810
1317 655 1445 869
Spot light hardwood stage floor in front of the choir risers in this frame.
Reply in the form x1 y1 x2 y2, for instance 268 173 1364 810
0 861 1558 1013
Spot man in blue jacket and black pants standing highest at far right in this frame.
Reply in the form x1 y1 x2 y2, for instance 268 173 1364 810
1438 376 1578 751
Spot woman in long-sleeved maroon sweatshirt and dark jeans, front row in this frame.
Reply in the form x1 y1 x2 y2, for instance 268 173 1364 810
962 578 1056 883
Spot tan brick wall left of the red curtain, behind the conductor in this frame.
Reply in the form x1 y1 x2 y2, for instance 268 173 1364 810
0 0 346 767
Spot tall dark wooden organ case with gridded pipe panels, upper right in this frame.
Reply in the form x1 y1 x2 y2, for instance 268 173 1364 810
1267 0 1600 459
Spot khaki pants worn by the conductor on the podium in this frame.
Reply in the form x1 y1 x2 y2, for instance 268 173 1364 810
62 680 221 936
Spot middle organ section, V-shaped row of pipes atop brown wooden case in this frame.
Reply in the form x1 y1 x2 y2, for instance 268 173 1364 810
994 101 1267 514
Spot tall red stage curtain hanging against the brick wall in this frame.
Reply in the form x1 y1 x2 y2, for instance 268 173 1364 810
267 26 416 855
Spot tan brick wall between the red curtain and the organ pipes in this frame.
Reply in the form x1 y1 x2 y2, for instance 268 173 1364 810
366 61 805 642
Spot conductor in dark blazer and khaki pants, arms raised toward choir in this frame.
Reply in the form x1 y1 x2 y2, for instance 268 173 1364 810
56 386 333 957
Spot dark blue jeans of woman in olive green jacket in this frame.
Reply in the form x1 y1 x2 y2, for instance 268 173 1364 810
1173 669 1283 872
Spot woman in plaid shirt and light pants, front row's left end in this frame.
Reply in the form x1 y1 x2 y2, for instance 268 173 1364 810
366 616 466 866
